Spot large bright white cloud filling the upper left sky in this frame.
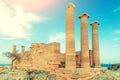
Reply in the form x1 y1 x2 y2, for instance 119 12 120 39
0 0 47 40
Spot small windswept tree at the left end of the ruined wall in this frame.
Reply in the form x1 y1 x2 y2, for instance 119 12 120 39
3 51 21 69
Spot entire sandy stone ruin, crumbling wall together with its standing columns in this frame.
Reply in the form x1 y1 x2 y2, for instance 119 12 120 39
12 3 100 80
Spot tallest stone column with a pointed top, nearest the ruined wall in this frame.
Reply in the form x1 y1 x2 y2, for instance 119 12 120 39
66 3 76 71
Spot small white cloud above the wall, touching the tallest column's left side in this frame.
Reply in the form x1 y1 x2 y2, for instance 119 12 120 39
49 32 65 52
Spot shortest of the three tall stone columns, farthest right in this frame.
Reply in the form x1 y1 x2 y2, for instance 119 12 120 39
91 22 100 67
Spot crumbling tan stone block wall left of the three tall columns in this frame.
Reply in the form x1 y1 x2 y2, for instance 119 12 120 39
13 42 63 69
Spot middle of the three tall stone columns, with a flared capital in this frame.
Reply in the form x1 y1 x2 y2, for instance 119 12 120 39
79 13 90 68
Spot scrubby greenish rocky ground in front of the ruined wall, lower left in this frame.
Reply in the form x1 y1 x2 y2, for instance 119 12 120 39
0 69 56 80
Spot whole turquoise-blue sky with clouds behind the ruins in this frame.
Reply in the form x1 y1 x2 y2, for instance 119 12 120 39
0 0 120 63
